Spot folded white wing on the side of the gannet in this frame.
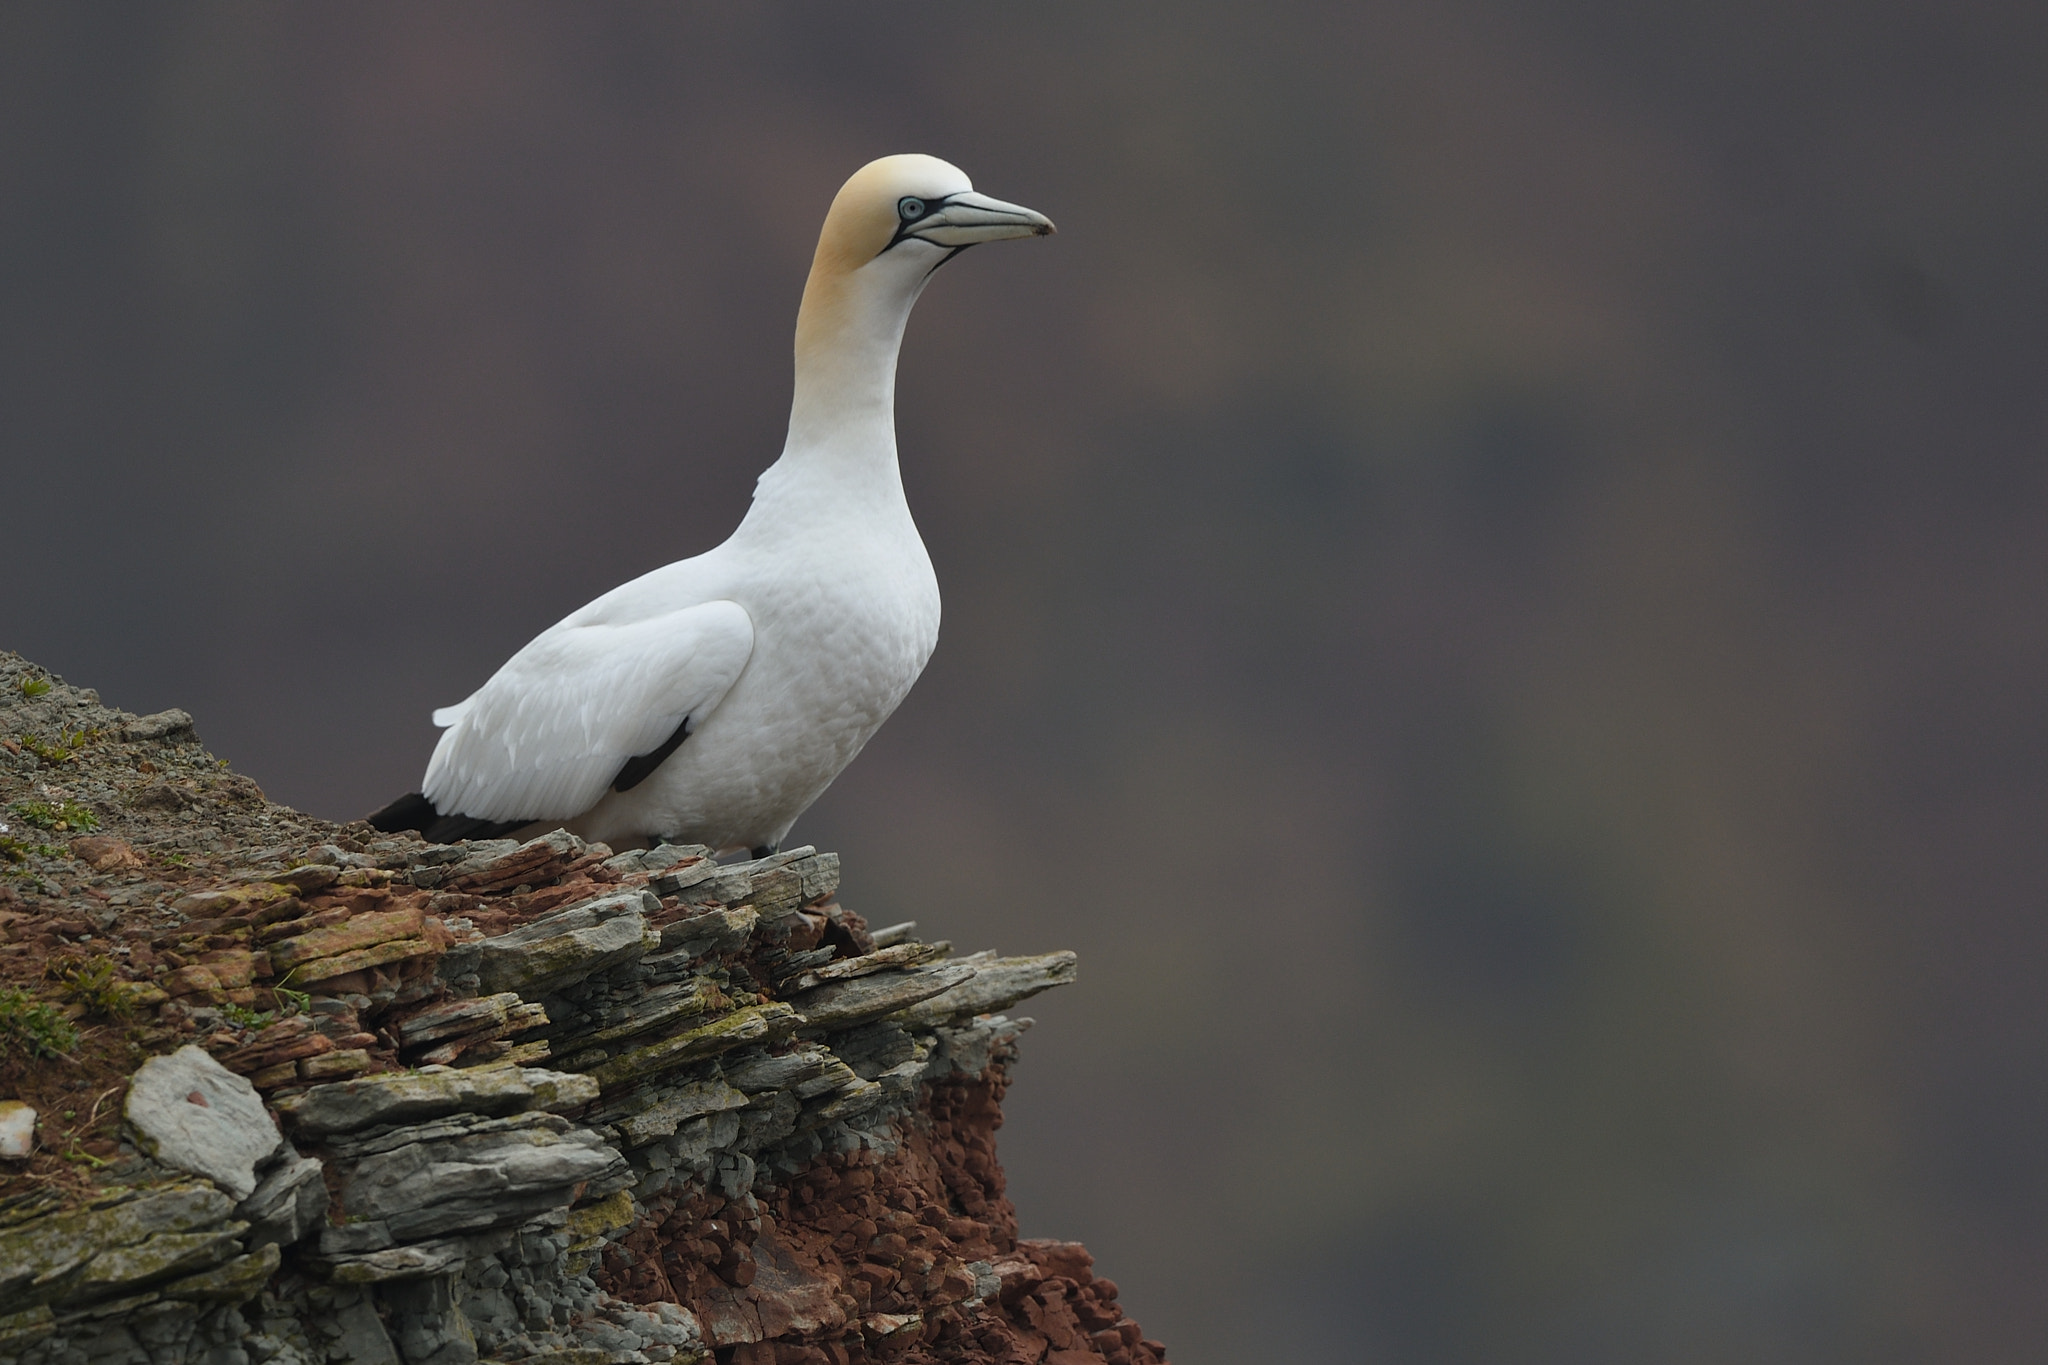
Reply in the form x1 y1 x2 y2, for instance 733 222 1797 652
424 602 754 821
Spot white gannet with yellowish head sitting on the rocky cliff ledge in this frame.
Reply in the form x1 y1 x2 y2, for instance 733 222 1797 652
369 156 1053 855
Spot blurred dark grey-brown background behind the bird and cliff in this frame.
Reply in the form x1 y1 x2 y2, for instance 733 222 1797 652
0 0 2048 1365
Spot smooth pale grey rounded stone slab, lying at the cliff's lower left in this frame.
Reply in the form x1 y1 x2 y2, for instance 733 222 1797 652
125 1044 283 1199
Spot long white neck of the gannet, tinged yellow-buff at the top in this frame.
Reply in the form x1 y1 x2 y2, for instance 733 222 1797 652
764 270 922 501
